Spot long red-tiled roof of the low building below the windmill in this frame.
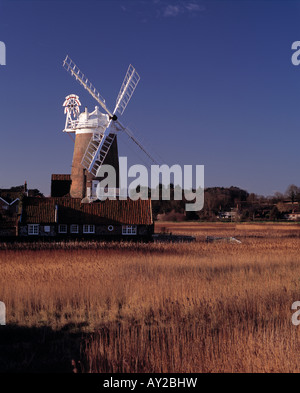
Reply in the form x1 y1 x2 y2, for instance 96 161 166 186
21 197 153 225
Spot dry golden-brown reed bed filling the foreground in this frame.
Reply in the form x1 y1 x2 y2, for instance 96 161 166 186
0 223 300 372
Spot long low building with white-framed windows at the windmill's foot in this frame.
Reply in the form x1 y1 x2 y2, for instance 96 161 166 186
18 197 154 238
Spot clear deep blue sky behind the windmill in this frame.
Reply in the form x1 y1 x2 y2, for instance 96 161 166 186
0 0 300 195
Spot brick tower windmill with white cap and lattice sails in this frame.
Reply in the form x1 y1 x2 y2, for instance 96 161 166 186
63 56 157 199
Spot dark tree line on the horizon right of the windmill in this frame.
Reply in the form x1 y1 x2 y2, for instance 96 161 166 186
152 184 300 221
